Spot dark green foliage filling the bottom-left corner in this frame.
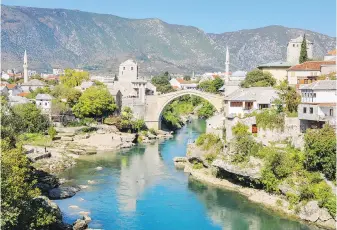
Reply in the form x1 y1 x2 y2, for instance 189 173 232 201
1 144 56 229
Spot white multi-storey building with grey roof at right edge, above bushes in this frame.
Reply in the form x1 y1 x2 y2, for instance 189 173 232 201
298 80 337 132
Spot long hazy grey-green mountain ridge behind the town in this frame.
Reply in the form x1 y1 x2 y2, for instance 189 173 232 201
1 5 336 75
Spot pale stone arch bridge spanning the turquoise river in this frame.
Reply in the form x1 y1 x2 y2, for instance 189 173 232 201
144 89 224 129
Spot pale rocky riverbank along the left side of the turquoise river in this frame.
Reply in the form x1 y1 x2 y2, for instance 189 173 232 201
23 125 173 230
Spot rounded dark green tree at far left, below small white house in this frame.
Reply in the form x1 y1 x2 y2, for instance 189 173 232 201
13 103 49 133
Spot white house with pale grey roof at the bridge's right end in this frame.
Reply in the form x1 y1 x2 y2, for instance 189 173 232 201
225 87 278 118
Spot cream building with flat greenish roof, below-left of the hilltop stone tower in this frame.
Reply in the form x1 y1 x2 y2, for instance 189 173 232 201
257 61 292 82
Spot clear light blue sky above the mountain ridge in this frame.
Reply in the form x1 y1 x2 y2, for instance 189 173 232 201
2 0 336 36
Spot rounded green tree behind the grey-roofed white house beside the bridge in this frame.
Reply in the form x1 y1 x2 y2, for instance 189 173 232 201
241 69 276 88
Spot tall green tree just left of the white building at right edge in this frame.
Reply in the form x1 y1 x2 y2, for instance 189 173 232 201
276 80 301 114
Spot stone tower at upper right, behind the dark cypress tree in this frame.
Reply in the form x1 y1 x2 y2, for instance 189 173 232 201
287 35 314 65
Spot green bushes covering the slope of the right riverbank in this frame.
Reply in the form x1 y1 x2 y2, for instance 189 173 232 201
188 123 336 226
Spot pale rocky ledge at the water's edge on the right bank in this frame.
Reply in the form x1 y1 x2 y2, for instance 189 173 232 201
174 144 336 229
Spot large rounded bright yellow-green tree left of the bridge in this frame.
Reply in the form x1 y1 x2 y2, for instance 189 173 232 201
73 86 117 118
